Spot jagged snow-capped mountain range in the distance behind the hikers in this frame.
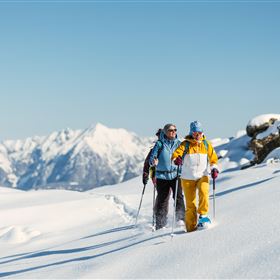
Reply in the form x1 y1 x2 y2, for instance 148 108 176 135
0 124 152 190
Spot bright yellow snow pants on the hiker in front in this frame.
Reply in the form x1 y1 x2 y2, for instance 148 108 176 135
181 176 209 232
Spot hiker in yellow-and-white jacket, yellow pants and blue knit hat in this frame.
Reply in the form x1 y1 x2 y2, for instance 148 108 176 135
171 121 219 232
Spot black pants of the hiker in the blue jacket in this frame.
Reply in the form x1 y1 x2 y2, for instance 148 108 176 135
154 178 185 229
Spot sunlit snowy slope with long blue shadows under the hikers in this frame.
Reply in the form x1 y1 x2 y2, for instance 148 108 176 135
0 159 280 279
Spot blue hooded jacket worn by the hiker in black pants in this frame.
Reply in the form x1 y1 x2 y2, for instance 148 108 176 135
149 131 181 180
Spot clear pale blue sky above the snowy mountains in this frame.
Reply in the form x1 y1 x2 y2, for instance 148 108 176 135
0 0 280 140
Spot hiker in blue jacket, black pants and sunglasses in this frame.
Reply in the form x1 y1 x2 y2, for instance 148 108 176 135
149 123 185 230
